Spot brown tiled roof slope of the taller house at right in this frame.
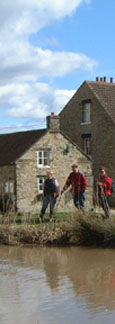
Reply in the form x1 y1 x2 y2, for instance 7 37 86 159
86 81 115 122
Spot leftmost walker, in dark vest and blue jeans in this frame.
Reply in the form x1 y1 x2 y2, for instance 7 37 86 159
40 171 59 221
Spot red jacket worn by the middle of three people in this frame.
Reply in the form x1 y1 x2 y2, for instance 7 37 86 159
63 171 88 195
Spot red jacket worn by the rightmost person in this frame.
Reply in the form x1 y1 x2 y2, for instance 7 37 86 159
97 173 112 196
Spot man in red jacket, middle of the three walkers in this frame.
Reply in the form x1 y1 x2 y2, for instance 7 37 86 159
61 164 88 209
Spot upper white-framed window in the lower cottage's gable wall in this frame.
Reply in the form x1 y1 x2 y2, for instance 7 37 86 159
37 150 50 167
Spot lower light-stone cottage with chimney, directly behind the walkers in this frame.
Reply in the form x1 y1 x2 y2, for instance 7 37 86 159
0 114 93 213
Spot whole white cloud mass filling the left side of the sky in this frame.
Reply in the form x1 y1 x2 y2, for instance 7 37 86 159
0 0 97 133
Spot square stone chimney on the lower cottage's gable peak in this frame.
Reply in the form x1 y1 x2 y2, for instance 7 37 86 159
46 112 60 133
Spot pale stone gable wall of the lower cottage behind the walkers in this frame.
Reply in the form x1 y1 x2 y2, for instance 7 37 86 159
16 131 93 213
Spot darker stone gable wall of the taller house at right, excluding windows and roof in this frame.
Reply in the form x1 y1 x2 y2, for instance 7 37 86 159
60 83 115 206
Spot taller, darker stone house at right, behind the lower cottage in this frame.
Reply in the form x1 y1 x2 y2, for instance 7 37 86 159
59 77 115 202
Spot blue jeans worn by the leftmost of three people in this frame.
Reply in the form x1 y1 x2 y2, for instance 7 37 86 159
41 196 56 218
